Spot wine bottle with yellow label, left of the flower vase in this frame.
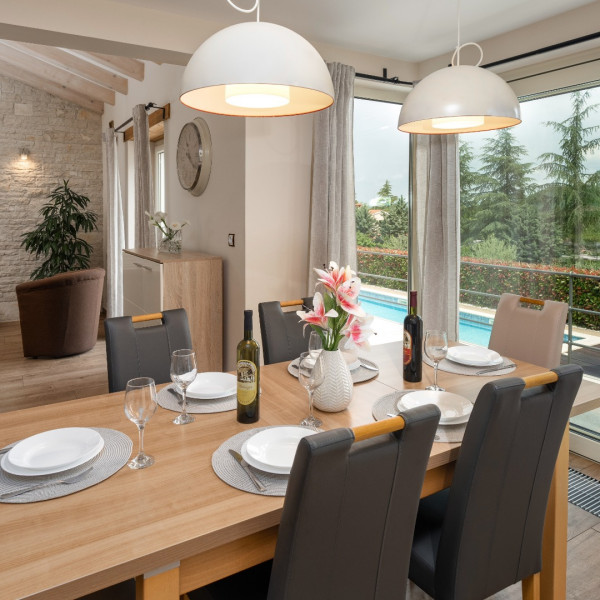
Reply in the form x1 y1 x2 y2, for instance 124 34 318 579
237 310 260 423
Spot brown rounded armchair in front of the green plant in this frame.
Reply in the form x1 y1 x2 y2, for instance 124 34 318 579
16 268 105 358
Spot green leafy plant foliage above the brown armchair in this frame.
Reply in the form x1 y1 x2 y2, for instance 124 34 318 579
21 180 98 279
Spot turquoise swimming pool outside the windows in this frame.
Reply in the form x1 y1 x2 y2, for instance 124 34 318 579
360 290 581 347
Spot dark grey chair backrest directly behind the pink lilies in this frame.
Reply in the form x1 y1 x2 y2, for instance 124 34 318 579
258 298 313 365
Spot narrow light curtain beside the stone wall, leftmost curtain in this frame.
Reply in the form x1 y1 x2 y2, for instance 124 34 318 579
102 127 125 317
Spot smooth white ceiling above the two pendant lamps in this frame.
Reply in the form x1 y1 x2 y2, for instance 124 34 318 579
115 0 595 62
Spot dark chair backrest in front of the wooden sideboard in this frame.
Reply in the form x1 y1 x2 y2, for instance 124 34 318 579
104 308 192 392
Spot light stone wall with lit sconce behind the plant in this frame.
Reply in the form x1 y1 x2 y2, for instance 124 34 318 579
0 76 103 321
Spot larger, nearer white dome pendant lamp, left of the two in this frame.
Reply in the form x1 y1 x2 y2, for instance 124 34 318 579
180 0 333 117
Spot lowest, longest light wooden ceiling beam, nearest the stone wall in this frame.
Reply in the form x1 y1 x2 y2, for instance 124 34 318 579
0 42 115 104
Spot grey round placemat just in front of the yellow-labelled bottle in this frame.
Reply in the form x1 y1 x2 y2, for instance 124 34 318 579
212 427 304 496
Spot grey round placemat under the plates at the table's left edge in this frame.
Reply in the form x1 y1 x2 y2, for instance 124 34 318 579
0 427 133 504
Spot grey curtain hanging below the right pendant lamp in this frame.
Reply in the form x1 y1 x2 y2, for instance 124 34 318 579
411 135 460 340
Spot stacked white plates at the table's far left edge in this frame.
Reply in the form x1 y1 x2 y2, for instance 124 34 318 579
0 427 104 476
